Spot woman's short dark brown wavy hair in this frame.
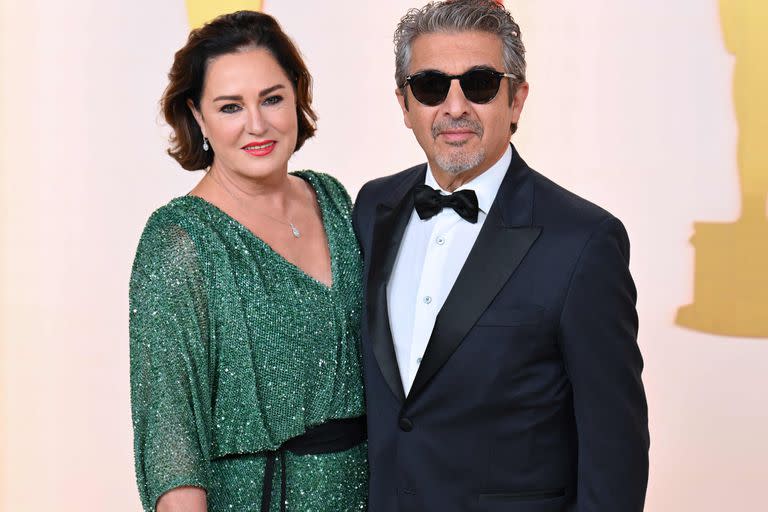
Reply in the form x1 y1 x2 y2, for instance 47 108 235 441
160 11 317 171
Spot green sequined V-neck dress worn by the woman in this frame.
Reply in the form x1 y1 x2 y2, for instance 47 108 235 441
130 171 368 512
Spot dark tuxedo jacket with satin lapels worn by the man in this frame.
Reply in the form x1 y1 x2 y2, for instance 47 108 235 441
354 148 649 512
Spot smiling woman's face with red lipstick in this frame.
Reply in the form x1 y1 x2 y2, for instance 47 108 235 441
190 48 298 178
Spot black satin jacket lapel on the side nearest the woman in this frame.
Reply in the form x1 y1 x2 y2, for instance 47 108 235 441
366 166 426 402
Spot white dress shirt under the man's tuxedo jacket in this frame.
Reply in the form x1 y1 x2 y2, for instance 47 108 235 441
387 146 512 395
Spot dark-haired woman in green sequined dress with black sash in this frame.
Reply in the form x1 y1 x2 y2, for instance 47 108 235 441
130 11 367 512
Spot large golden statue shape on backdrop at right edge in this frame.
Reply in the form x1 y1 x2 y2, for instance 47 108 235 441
677 0 768 338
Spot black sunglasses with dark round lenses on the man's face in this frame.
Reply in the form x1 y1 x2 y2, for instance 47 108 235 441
403 68 517 107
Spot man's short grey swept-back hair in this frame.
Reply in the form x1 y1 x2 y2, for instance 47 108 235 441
395 0 525 94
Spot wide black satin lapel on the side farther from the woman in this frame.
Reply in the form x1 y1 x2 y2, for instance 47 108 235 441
406 152 541 406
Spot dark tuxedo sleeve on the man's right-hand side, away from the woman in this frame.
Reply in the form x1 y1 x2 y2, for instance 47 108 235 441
560 217 649 512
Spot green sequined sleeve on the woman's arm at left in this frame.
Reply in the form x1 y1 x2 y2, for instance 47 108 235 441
130 220 211 511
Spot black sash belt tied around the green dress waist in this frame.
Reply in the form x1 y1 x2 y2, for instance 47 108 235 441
261 416 368 512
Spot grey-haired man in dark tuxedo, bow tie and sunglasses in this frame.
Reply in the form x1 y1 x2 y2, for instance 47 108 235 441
354 0 648 512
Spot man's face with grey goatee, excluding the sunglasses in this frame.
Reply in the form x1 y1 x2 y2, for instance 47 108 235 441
397 32 528 182
